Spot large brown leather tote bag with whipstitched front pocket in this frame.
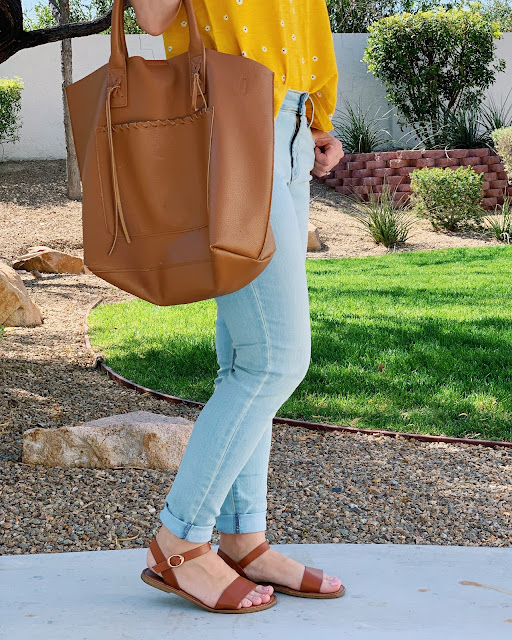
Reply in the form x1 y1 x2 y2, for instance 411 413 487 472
65 0 276 306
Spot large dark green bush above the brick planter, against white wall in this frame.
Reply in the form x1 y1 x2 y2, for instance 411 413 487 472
363 3 505 148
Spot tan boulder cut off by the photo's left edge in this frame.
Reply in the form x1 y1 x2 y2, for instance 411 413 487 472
0 262 43 327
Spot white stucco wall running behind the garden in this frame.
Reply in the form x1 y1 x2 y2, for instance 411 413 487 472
0 33 512 161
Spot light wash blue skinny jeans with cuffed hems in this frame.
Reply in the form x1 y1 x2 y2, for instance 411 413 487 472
159 89 315 542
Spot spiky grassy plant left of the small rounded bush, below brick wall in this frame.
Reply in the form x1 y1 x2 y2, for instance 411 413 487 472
348 178 415 248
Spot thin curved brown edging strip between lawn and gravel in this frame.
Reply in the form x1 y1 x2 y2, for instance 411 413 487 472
84 297 512 448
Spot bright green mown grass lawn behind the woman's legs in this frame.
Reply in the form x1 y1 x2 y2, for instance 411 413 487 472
89 246 512 440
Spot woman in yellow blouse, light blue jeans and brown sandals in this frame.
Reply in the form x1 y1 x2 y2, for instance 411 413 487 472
132 0 345 613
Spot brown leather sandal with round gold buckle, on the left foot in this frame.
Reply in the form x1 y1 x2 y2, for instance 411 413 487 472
140 538 277 613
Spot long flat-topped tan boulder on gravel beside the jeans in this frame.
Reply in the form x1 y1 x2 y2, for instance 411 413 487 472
23 411 194 471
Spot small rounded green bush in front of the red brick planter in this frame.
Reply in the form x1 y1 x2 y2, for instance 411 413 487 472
410 166 484 231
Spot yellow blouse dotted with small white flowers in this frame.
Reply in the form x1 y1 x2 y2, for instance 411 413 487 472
162 0 338 131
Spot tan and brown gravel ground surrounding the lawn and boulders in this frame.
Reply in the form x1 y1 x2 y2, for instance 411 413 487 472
0 161 512 554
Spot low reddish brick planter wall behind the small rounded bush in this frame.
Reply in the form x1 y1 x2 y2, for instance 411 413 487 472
316 149 512 209
